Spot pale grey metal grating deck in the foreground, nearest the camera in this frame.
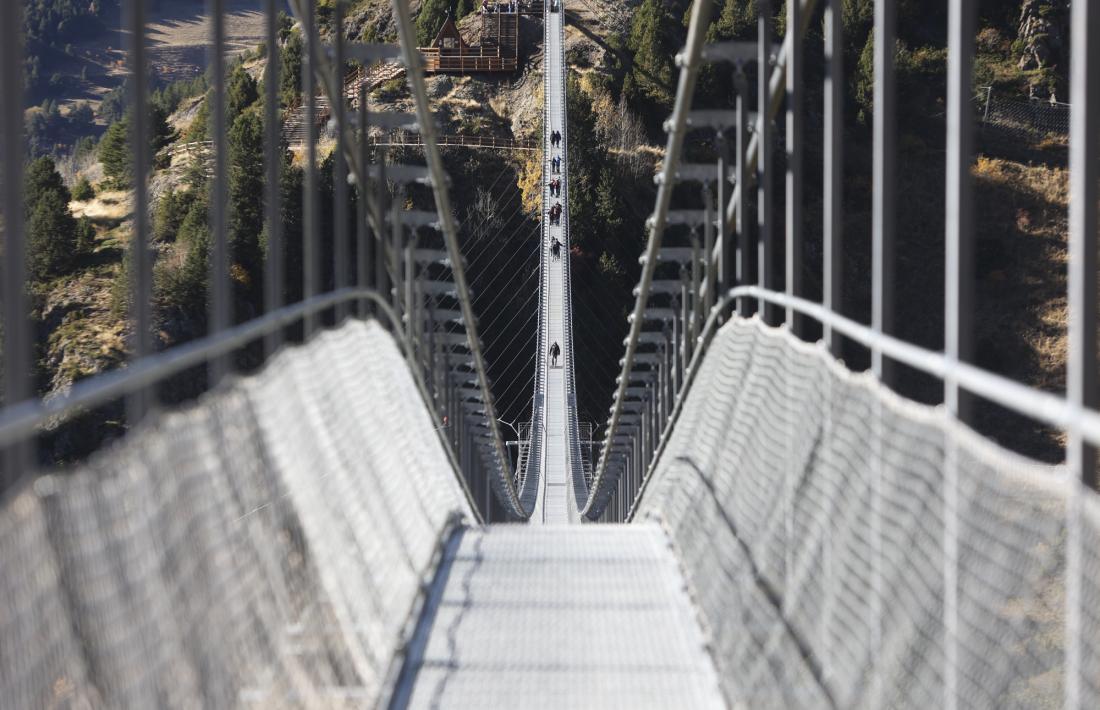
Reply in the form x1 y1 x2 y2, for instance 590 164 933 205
397 525 725 709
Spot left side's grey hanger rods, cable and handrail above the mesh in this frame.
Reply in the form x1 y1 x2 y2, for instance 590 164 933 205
0 1 525 517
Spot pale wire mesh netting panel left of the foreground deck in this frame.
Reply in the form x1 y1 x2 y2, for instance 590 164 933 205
0 323 470 708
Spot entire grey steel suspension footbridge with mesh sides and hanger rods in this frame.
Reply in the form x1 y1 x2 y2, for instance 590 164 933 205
0 0 1100 709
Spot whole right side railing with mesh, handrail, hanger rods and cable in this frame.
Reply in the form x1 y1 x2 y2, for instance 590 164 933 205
598 0 1100 708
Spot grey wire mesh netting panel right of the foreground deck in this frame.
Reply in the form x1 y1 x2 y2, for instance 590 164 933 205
638 319 1082 708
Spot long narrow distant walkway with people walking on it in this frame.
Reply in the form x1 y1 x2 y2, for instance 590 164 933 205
530 4 579 524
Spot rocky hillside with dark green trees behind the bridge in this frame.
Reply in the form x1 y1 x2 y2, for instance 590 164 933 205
21 0 1066 460
